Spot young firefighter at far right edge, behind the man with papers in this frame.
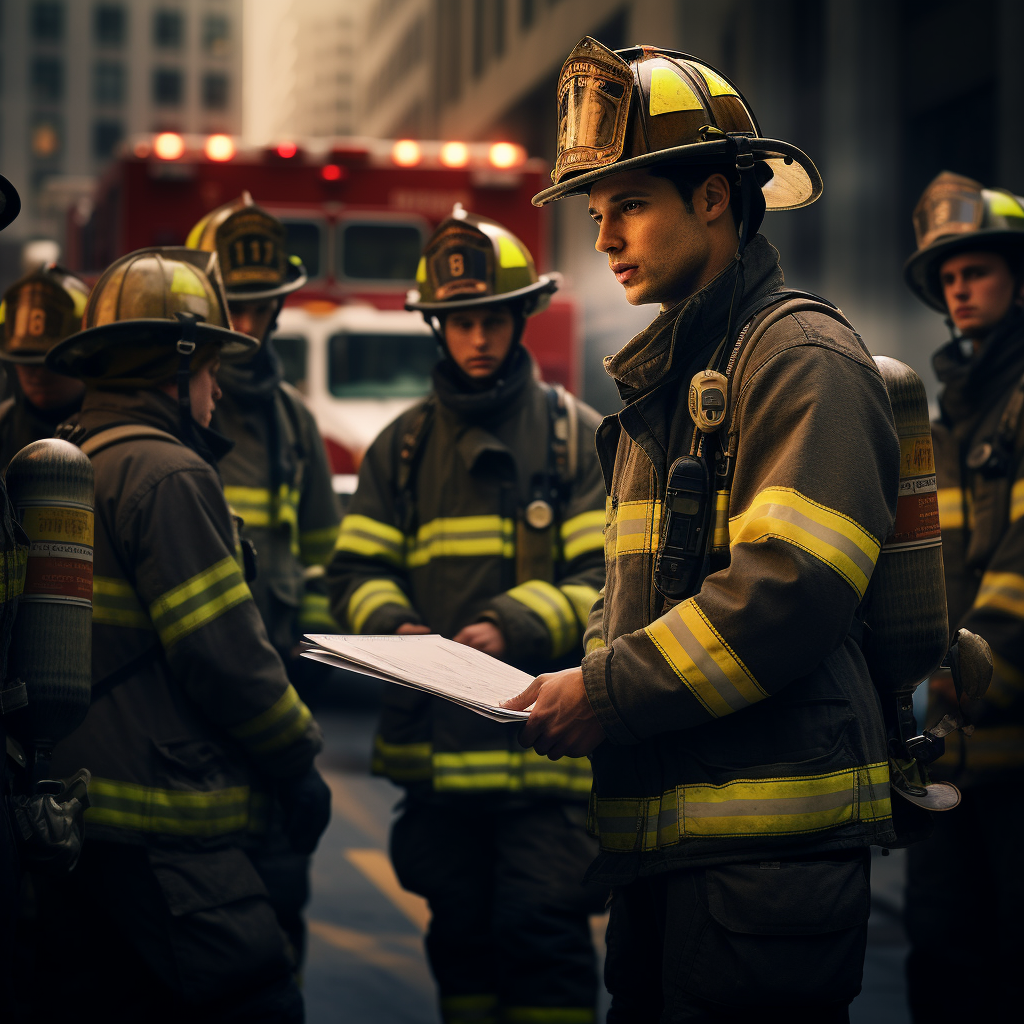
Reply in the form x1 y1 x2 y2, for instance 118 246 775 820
905 171 1024 1022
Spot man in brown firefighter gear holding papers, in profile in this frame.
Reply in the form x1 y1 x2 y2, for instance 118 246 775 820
510 38 899 1024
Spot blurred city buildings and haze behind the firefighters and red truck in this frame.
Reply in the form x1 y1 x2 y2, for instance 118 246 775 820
0 0 1024 411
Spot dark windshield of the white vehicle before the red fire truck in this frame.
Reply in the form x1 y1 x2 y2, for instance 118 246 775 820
328 332 437 398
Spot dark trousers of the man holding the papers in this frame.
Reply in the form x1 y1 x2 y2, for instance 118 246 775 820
604 850 870 1024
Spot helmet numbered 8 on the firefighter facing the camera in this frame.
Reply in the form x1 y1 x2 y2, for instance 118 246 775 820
406 203 560 316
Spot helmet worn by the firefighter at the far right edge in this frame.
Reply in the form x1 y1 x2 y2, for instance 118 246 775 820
903 171 1024 313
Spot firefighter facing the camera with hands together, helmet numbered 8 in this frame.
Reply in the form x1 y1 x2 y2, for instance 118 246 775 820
328 206 604 1024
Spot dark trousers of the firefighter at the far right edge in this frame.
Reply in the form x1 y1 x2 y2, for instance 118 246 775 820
905 783 1024 1024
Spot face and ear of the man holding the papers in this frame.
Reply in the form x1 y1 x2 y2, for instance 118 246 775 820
590 169 738 309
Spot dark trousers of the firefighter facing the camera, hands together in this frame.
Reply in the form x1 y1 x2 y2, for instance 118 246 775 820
391 797 605 1024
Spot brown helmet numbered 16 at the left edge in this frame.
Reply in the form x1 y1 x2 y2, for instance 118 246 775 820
0 263 89 364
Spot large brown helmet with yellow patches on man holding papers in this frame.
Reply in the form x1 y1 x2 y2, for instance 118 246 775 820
534 36 821 210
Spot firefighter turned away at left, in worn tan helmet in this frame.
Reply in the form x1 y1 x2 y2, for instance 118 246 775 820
33 248 329 1022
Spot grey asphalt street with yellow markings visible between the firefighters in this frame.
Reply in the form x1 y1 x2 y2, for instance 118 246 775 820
304 692 909 1024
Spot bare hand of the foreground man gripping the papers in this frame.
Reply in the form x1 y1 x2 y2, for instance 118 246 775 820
502 669 605 761
